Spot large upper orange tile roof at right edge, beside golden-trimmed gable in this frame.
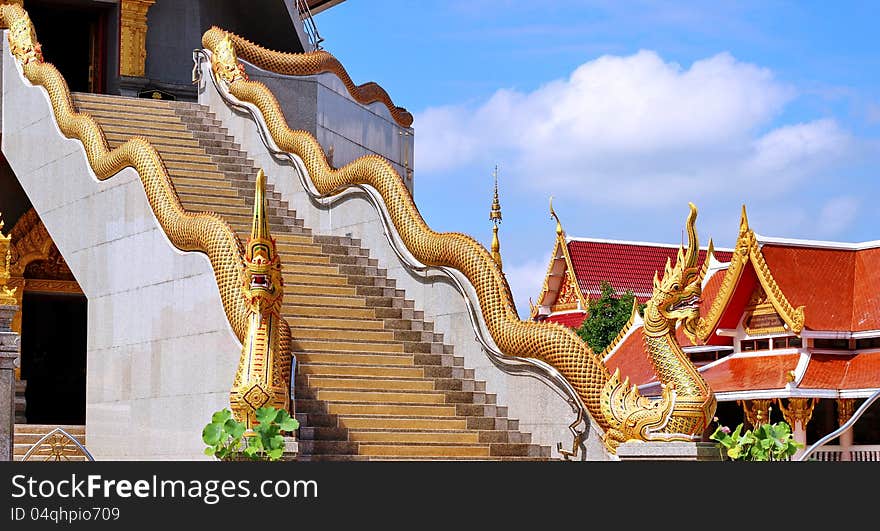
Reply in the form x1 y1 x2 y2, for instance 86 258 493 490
761 243 880 332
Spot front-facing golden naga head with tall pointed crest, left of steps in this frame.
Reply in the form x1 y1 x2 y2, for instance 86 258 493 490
243 169 284 315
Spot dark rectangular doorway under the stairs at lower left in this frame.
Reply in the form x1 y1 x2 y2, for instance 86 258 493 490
21 292 87 425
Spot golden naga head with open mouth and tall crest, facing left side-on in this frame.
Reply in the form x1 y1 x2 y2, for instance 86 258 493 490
651 203 714 343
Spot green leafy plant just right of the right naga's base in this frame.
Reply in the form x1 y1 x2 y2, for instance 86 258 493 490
709 418 804 461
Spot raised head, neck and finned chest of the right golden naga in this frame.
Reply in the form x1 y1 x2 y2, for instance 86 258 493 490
602 203 716 448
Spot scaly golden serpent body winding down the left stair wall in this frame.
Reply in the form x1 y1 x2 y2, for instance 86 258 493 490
0 4 293 420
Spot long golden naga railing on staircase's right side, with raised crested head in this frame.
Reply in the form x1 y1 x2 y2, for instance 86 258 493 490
202 28 715 452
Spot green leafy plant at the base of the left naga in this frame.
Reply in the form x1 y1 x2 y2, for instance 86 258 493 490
202 407 299 461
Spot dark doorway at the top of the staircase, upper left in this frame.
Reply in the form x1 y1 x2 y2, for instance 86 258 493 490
25 1 107 93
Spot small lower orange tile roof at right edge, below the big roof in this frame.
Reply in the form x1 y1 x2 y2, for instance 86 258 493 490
798 351 880 390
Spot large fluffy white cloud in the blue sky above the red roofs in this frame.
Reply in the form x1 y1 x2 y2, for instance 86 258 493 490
415 51 852 207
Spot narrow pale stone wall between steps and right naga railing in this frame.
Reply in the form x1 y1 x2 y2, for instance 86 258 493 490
199 57 609 460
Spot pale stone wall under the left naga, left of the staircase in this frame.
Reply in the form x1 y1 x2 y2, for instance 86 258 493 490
2 43 241 460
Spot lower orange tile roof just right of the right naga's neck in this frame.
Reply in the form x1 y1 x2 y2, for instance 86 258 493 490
701 353 800 393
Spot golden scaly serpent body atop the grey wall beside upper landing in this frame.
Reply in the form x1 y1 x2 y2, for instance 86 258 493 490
202 27 413 127
